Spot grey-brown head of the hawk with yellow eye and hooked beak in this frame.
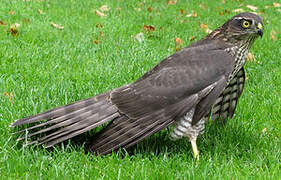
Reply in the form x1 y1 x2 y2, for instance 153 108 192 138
210 12 263 43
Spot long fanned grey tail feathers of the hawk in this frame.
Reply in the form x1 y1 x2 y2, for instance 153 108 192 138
10 93 120 147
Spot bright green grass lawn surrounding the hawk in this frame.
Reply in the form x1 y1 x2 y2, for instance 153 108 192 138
0 0 281 179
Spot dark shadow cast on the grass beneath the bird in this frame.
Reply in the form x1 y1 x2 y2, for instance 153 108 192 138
10 121 260 158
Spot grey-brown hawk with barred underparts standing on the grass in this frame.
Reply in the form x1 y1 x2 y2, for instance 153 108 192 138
11 13 263 158
